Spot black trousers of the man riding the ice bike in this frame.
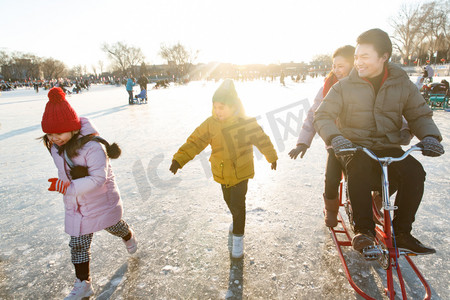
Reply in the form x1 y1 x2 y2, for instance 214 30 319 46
340 149 426 233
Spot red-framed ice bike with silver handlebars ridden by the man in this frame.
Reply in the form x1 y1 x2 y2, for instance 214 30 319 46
329 146 431 299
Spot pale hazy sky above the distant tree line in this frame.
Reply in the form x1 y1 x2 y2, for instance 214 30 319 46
0 0 426 68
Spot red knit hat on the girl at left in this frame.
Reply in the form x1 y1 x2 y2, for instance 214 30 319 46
41 87 81 133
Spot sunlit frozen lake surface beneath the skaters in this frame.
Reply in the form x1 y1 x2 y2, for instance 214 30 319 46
0 78 450 299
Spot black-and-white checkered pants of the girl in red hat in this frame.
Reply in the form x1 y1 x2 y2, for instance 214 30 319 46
69 220 130 264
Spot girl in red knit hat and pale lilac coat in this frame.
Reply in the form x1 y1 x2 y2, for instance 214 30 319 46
41 87 137 299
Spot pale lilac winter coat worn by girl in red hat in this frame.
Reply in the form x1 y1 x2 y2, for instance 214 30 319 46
51 118 123 236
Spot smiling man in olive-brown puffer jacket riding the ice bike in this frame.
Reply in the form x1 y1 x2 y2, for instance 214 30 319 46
314 29 444 254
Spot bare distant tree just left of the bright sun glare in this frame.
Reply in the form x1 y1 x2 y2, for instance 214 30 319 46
159 42 199 77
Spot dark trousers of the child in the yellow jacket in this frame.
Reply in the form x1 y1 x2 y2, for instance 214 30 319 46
222 179 248 234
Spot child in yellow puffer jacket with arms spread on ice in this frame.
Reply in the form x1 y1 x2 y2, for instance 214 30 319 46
170 79 278 258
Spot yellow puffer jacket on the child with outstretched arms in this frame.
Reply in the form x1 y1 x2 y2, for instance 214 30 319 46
173 115 278 187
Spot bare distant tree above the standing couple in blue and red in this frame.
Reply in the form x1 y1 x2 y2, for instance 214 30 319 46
102 42 145 75
